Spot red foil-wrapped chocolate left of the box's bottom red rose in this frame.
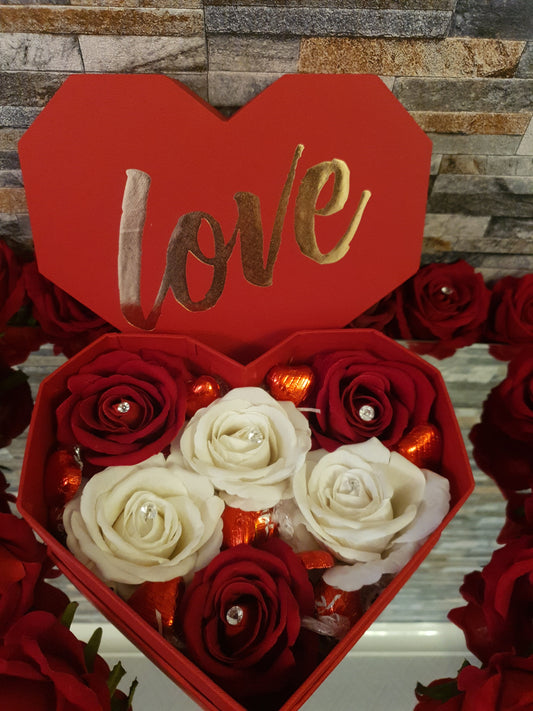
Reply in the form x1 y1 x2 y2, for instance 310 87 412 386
128 578 185 633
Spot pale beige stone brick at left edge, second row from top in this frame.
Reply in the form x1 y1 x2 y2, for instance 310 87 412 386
0 33 83 72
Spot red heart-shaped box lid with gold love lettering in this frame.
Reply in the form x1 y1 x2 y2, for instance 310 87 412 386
19 75 431 361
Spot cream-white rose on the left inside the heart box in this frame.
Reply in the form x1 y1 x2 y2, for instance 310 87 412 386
63 454 224 585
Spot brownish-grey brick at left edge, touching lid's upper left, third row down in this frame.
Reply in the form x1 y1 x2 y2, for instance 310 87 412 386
0 71 68 106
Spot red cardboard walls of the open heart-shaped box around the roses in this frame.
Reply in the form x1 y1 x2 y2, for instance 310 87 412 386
18 330 473 711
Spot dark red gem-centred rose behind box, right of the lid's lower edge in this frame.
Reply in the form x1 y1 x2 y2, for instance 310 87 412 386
397 260 490 358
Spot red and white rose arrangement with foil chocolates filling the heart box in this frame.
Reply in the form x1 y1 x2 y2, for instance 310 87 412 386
45 349 449 705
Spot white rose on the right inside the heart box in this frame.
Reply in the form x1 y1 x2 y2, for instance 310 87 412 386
294 438 450 590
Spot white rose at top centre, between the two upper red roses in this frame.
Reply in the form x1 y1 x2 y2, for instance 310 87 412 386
171 387 311 511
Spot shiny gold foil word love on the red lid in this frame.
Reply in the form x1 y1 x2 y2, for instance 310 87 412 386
118 145 370 330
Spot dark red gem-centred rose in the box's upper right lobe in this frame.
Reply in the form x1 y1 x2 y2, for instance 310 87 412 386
310 351 435 451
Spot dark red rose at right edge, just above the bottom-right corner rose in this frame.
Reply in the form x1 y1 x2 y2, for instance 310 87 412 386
448 536 533 664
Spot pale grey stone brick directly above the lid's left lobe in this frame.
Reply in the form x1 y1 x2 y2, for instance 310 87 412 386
79 35 207 73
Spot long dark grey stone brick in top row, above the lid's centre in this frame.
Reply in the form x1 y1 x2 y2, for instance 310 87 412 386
205 6 450 37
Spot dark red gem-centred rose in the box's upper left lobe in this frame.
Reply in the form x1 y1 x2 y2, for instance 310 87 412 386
57 348 190 467
